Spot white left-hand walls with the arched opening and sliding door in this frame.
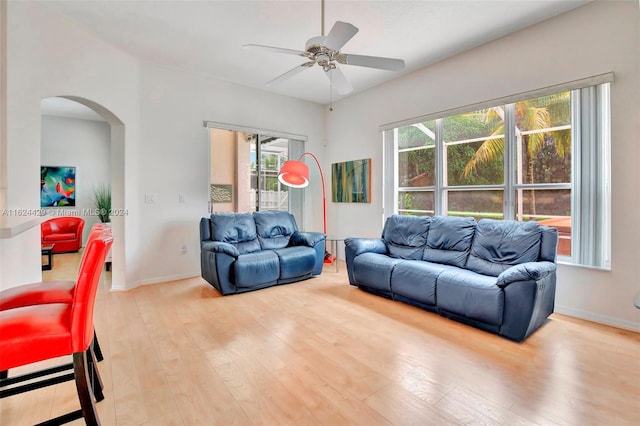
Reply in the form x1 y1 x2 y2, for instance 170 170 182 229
0 2 323 289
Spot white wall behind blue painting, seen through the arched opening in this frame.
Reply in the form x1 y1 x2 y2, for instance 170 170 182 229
40 115 111 241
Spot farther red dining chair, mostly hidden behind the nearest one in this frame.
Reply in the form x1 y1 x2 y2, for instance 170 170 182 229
0 223 111 380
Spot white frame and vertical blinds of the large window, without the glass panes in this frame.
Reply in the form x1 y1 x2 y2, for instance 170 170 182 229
380 73 614 270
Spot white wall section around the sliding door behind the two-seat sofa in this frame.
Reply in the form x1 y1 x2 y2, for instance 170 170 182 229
140 65 323 283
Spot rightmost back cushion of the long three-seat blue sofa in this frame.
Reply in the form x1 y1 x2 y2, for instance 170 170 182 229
466 219 541 277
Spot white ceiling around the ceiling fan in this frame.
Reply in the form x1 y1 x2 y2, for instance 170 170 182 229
41 0 590 104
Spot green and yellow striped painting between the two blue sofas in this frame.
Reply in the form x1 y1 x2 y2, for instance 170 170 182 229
331 158 371 203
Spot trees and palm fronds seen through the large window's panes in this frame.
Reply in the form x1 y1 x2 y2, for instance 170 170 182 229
398 92 571 218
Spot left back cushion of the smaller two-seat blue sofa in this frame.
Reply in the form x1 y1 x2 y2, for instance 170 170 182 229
211 213 260 254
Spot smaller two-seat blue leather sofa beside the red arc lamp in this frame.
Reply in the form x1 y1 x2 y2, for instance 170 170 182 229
200 211 326 295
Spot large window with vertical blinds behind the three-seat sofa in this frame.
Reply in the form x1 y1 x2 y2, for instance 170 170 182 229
384 75 611 269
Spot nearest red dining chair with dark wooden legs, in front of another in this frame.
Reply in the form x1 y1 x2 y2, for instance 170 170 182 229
0 231 113 425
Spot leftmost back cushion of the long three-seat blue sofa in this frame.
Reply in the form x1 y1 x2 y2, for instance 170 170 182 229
382 215 431 259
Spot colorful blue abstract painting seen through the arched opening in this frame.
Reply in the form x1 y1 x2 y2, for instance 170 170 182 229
40 166 76 207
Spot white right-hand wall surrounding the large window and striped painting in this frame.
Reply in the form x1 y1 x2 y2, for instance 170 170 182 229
325 2 640 329
